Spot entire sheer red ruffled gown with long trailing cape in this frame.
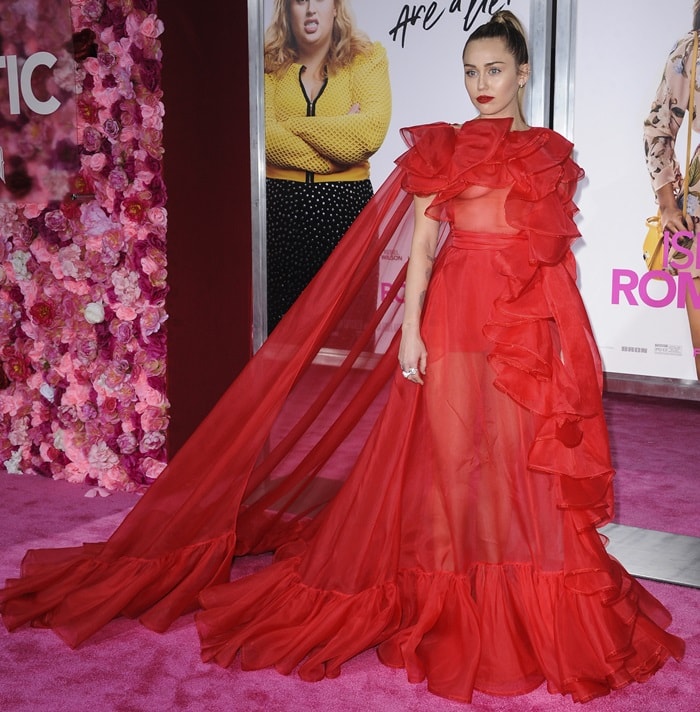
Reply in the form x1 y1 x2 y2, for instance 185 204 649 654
0 119 683 701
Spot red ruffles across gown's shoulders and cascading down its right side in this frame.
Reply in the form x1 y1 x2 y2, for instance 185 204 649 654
397 119 613 529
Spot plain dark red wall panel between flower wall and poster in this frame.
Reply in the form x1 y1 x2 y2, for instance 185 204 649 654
158 0 252 457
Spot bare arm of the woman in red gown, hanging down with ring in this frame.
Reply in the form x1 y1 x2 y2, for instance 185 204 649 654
399 195 440 384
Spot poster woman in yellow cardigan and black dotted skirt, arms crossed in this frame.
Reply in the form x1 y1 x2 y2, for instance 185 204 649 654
265 0 391 330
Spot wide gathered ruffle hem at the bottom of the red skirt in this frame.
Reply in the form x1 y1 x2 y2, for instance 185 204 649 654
196 558 683 702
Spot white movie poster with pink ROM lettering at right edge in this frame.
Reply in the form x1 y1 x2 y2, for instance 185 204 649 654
568 0 700 381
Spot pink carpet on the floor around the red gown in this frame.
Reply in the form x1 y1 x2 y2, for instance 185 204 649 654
0 396 700 712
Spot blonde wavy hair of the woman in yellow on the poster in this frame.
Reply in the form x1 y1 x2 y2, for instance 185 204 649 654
265 0 372 74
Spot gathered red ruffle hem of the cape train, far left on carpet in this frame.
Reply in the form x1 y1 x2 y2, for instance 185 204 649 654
0 534 235 648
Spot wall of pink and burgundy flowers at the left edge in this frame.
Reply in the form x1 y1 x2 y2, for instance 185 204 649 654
0 0 168 490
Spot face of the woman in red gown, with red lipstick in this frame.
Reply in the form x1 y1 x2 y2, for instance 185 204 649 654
464 37 529 119
